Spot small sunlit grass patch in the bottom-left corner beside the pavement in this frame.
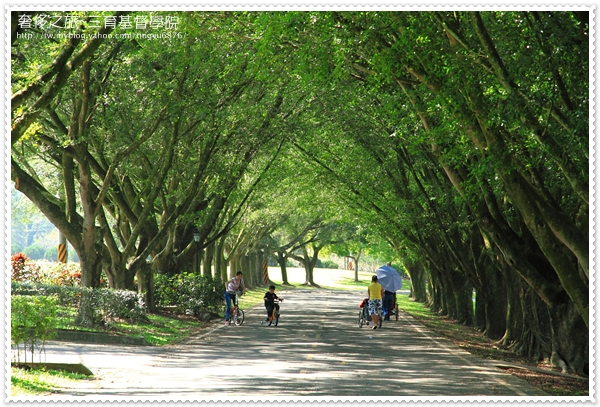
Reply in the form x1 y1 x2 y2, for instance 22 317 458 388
10 367 91 397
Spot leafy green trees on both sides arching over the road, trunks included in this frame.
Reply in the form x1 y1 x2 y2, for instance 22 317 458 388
10 7 591 376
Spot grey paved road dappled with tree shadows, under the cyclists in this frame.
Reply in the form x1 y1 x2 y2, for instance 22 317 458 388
28 290 546 400
